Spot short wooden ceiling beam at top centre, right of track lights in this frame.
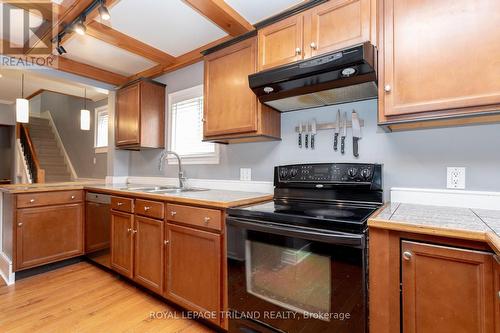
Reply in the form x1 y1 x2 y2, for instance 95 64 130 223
184 0 254 37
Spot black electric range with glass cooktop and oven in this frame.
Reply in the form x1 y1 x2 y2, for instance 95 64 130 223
227 163 383 333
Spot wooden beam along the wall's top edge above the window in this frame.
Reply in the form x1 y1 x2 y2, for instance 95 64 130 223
128 36 232 81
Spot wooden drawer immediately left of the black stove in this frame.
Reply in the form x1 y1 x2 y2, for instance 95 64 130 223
167 204 222 230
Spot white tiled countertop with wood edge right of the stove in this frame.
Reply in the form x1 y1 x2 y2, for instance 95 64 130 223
368 202 500 255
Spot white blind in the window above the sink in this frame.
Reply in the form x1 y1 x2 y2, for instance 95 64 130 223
170 86 217 163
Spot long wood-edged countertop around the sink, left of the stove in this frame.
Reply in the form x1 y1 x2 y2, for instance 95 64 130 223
0 182 273 208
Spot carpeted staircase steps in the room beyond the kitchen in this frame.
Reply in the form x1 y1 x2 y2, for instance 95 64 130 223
28 117 71 183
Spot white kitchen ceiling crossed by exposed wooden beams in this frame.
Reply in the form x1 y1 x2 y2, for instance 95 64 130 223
0 0 304 85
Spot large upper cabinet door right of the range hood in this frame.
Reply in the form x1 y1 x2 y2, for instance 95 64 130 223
379 0 500 116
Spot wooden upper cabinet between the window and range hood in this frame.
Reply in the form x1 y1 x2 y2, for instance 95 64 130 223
203 37 281 143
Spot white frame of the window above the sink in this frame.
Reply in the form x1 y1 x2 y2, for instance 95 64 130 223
167 84 220 164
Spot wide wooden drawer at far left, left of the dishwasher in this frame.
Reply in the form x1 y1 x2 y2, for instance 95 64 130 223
17 191 83 208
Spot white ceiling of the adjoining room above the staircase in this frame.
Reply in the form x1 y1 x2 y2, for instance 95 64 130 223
0 69 108 104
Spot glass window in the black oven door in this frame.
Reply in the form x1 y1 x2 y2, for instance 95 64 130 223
245 238 332 313
